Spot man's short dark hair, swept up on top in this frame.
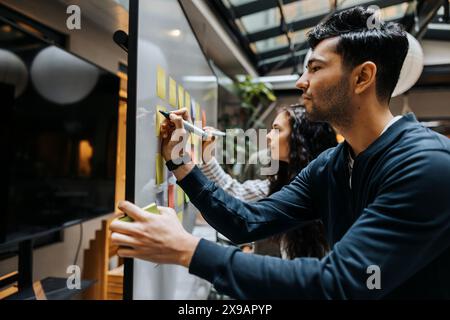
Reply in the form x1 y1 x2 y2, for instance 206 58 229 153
308 6 409 101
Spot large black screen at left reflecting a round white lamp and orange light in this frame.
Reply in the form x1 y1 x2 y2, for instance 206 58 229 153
0 23 120 247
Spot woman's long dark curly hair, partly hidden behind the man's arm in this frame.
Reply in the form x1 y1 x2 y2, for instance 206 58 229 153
269 105 337 259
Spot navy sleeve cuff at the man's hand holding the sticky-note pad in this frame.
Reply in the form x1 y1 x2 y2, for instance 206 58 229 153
189 239 233 283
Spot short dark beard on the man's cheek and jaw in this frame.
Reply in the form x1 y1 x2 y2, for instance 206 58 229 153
307 77 353 128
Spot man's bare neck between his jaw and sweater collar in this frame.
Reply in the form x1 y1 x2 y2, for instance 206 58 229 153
337 106 394 156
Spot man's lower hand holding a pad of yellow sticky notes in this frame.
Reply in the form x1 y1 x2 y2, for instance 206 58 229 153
110 201 200 268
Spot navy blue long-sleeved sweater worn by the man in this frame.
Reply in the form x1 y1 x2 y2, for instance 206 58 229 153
179 114 450 299
